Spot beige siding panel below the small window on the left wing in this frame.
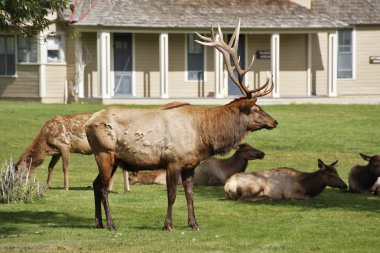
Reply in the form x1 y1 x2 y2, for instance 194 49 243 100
46 64 67 99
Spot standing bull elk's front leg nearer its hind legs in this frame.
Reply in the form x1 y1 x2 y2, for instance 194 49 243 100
164 168 179 231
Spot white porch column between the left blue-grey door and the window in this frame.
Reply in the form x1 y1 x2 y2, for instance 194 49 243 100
160 33 169 98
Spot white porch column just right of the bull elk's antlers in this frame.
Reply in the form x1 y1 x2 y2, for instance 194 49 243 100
271 33 280 98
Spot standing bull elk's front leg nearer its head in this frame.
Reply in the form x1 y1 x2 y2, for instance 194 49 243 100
181 169 200 230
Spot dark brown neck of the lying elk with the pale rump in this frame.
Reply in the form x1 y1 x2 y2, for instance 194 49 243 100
299 170 326 197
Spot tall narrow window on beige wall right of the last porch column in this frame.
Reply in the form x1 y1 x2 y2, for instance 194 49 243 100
337 29 353 78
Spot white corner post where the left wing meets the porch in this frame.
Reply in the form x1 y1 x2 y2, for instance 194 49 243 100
75 36 86 98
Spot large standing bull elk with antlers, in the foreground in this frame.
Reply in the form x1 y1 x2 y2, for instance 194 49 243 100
86 21 277 230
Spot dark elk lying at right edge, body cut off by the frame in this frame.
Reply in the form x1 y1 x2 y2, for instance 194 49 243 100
348 153 380 195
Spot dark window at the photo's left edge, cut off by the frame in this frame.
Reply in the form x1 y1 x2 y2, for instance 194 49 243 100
0 35 16 76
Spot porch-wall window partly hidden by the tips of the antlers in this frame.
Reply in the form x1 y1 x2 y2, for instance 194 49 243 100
187 34 204 81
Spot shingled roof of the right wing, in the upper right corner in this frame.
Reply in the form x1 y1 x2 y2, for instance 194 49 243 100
311 0 380 25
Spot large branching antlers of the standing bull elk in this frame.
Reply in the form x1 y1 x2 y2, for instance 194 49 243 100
195 19 273 98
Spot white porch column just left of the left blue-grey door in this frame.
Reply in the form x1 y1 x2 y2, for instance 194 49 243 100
97 31 111 98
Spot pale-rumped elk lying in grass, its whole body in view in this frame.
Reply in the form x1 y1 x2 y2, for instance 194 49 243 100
224 159 347 201
